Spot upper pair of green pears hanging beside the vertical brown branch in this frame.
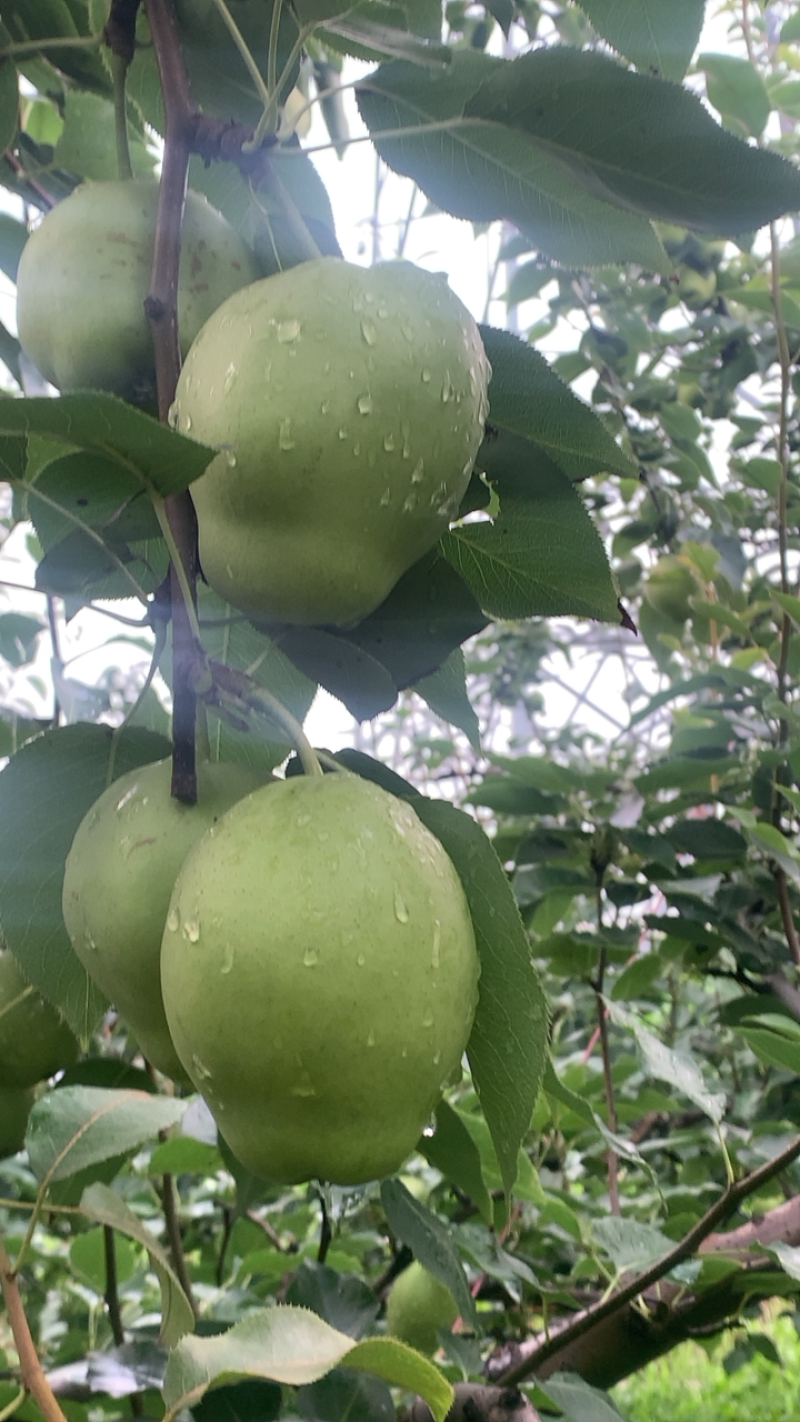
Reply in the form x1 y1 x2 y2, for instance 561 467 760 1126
17 181 490 626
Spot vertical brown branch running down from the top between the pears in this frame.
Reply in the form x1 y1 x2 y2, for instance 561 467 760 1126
145 0 199 805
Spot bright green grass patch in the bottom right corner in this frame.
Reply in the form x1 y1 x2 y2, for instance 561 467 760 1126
612 1301 800 1422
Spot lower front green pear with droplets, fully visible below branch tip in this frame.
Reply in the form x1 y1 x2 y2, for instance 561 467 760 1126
161 774 479 1185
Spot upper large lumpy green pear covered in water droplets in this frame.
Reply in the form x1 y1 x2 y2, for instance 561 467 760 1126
173 257 489 626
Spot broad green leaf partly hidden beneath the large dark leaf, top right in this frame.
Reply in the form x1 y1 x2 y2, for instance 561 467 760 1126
357 50 669 273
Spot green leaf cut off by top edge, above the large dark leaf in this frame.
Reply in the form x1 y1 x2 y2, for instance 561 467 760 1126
578 0 705 80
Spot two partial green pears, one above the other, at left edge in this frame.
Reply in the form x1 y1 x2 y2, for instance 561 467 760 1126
0 950 78 1158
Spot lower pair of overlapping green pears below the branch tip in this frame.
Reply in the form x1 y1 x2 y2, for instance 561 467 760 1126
64 762 479 1185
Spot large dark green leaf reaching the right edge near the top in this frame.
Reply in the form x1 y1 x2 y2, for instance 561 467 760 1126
465 48 800 236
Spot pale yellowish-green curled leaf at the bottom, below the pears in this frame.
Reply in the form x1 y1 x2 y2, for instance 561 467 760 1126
163 1304 453 1422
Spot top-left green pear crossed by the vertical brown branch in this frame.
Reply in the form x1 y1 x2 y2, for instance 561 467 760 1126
17 178 259 404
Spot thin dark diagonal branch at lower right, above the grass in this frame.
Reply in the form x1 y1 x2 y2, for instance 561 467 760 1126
490 1136 800 1386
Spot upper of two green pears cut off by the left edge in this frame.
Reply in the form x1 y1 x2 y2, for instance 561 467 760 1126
0 950 80 1086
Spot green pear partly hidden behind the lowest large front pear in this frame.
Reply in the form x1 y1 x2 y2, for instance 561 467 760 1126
63 761 264 1079
